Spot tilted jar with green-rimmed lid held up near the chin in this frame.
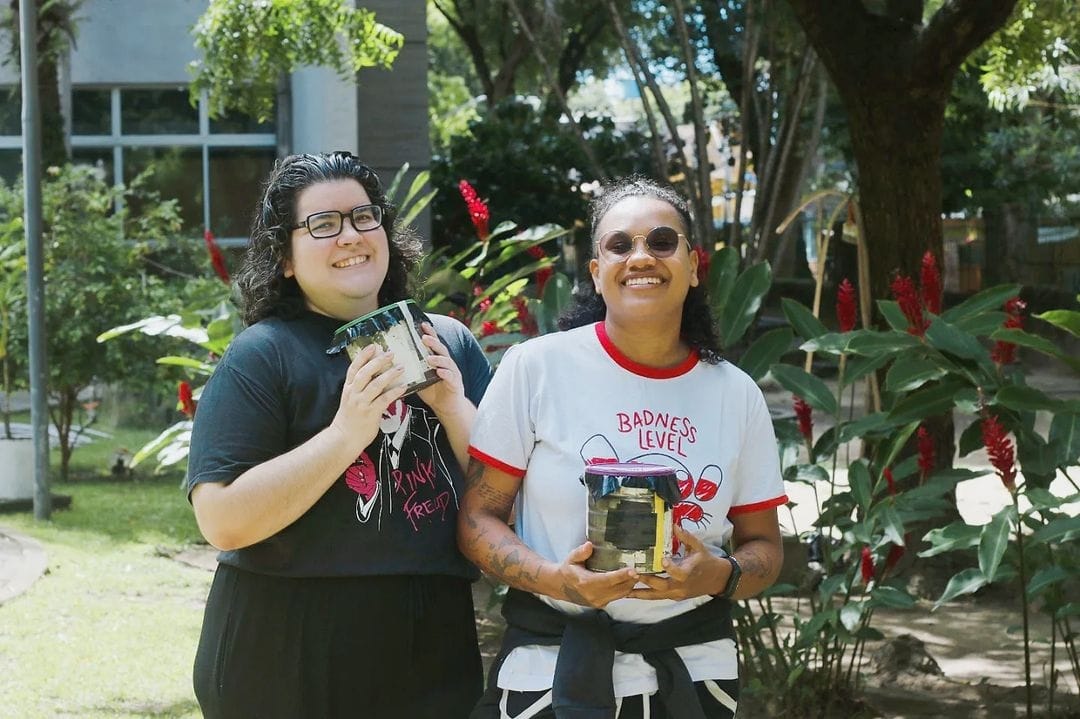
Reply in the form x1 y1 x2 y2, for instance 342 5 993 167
326 300 438 395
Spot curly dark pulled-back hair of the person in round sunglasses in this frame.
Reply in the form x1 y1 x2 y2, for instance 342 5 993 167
558 175 724 365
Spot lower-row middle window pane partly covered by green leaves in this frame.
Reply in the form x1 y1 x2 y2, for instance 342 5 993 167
124 147 203 234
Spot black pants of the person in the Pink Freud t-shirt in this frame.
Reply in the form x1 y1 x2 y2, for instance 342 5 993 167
194 566 483 719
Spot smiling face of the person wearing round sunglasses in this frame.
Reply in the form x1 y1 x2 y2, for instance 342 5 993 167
589 195 698 326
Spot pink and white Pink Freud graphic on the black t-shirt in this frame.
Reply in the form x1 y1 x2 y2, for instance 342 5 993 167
345 399 458 531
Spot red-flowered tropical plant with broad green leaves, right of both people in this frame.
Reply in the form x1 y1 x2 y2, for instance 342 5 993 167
710 245 1080 716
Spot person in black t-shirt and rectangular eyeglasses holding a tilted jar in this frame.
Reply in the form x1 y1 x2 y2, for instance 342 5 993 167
187 147 490 719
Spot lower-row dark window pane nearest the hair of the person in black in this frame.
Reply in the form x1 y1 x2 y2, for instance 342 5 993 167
210 147 274 238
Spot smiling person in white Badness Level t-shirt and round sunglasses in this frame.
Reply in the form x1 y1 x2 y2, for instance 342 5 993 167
458 178 786 719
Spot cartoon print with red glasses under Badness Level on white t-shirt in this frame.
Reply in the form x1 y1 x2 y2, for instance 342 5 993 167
580 425 724 552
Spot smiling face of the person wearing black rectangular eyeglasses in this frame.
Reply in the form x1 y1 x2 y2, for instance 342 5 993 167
285 179 390 320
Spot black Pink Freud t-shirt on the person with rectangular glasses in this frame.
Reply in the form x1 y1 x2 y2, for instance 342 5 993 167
187 312 491 578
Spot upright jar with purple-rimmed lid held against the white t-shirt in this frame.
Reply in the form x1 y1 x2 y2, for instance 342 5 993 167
582 462 679 574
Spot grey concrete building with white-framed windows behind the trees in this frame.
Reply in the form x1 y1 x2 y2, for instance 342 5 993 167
0 0 430 244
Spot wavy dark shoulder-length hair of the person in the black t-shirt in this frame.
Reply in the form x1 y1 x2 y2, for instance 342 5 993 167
235 151 421 325
